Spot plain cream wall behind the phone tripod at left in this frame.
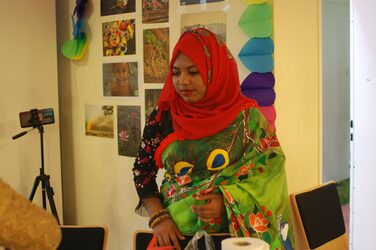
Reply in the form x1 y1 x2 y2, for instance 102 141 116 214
0 0 62 217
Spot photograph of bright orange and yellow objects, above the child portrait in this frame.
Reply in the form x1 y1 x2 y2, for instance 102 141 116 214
102 19 136 56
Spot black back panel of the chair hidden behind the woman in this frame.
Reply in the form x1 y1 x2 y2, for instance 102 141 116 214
136 232 231 250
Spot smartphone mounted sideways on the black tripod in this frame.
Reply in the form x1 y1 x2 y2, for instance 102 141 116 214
20 108 55 128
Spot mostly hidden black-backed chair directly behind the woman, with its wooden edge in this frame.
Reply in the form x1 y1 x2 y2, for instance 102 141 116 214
133 230 231 250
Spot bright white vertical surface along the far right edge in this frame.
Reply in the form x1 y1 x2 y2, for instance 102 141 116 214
350 0 376 250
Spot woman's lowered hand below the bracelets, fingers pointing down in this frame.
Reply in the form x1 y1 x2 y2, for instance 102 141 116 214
153 218 185 250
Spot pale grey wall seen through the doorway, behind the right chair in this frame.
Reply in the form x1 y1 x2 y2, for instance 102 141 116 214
322 0 350 182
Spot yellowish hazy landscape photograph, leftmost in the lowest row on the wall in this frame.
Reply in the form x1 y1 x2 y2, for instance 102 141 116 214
85 104 114 138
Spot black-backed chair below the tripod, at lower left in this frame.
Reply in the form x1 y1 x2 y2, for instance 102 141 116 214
58 225 108 250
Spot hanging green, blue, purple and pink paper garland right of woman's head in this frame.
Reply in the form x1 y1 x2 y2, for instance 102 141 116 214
238 0 276 127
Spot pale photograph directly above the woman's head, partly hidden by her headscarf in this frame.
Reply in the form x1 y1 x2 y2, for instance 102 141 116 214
180 11 226 42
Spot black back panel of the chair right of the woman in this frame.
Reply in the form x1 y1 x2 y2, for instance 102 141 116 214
296 183 346 249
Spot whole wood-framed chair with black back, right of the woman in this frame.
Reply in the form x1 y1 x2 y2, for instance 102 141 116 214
290 181 348 250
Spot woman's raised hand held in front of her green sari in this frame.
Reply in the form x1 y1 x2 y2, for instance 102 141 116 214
192 193 225 224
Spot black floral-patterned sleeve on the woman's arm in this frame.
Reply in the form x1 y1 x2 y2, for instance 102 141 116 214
132 109 172 205
